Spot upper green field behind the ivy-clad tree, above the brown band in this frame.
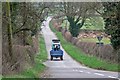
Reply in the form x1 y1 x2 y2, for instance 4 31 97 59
61 17 104 30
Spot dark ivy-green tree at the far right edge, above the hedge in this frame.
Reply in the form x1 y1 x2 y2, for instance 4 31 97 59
103 2 120 50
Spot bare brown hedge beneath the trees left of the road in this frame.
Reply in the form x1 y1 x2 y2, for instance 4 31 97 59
2 37 38 75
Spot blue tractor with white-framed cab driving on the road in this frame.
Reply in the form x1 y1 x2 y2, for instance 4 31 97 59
50 39 63 60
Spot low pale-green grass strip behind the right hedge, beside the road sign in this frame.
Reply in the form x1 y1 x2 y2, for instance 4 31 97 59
80 38 111 44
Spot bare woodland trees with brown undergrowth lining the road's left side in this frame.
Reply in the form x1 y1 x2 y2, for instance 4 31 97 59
2 2 50 74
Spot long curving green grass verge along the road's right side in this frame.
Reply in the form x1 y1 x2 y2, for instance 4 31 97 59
49 22 120 71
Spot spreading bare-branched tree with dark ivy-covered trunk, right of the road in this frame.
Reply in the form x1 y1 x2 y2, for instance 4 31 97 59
61 2 100 37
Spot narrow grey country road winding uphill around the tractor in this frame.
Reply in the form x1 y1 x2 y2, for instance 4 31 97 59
42 17 118 80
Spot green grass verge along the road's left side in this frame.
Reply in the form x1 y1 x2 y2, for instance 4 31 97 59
2 36 47 80
